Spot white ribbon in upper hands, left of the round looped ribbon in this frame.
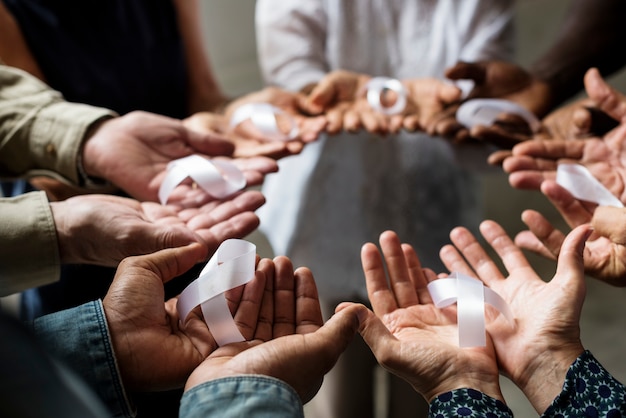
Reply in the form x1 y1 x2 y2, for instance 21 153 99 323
230 103 300 141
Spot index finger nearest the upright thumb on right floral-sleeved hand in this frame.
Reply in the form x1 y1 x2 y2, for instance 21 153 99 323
479 221 530 277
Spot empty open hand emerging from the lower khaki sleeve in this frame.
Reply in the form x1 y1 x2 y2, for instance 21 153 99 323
50 191 265 267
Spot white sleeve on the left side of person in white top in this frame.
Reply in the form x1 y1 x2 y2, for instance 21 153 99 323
255 0 329 90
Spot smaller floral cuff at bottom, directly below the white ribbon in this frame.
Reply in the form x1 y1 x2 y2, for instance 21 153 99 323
428 389 513 418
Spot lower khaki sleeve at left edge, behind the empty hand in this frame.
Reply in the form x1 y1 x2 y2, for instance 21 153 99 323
0 192 61 296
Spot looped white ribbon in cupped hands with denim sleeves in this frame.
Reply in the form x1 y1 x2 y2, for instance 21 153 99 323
176 239 256 346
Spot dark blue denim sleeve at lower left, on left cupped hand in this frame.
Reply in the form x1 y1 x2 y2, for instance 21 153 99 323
32 300 135 417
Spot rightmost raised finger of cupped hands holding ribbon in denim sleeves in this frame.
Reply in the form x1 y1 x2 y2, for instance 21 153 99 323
294 267 324 334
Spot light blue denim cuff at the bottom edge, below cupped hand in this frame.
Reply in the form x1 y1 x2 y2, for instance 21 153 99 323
178 375 304 418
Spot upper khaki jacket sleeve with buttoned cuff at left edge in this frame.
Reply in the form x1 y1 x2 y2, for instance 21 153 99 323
0 65 116 185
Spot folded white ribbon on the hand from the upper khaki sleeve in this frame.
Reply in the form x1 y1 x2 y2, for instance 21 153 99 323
159 155 246 205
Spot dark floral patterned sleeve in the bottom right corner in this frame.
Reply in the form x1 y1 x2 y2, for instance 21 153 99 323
541 351 626 418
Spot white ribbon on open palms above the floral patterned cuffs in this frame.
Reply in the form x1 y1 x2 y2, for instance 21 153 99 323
428 273 513 347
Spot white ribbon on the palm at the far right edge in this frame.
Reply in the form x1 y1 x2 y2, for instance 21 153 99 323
556 164 624 208
